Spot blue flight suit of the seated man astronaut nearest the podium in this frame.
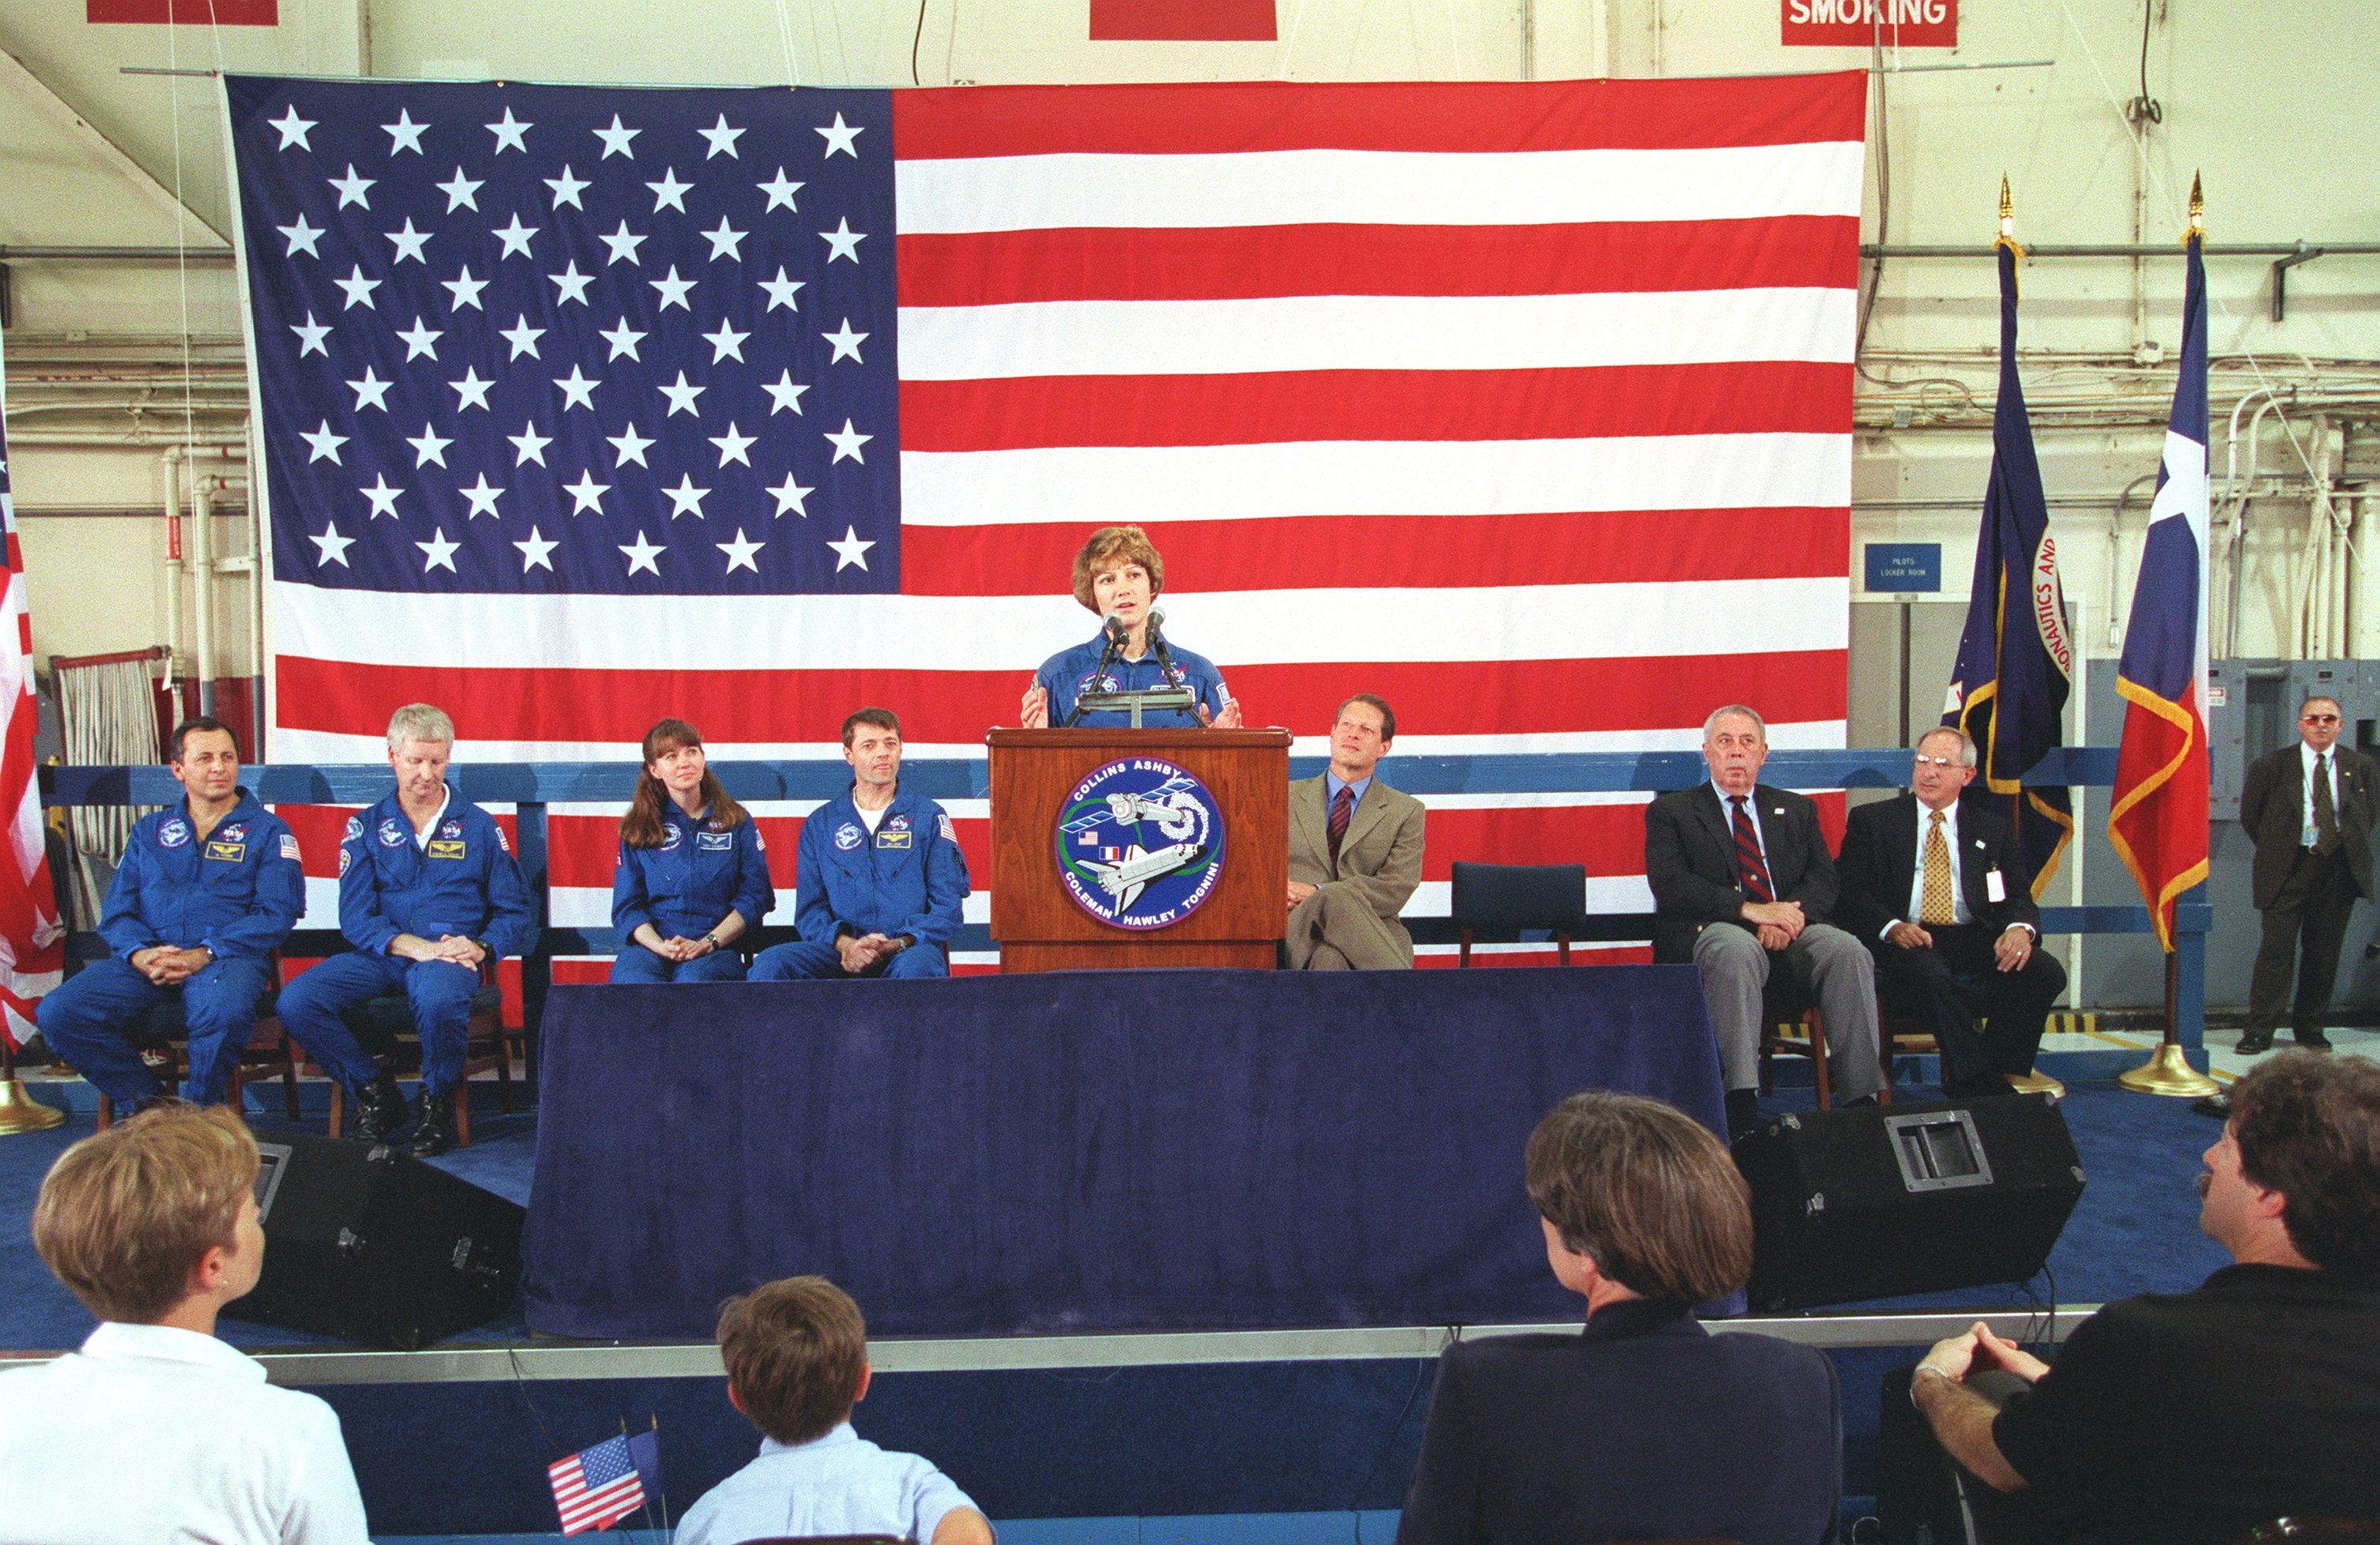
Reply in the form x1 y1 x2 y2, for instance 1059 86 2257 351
752 788 966 981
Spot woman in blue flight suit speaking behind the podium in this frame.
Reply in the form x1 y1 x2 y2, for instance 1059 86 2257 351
1021 526 1240 728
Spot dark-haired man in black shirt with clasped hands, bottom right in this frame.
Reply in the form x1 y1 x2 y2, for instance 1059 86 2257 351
1909 1052 2380 1545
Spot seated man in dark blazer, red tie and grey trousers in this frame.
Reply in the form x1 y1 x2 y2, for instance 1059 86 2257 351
1645 705 1885 1134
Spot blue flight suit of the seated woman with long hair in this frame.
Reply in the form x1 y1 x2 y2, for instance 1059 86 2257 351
612 800 776 981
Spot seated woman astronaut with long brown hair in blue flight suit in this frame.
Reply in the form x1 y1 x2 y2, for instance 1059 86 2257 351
612 719 776 981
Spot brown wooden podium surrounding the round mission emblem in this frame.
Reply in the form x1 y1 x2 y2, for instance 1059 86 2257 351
985 728 1290 971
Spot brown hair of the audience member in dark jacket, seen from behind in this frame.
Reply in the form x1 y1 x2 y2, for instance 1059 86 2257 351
1523 1090 1752 1305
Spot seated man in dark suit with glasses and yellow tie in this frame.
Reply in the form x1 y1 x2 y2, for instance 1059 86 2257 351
1835 728 2066 1100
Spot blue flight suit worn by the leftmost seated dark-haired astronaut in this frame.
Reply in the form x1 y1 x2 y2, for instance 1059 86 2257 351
33 788 305 1107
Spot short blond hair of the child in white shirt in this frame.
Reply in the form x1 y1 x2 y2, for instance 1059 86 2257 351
33 1104 257 1323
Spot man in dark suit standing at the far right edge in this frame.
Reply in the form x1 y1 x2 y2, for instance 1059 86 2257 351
2240 698 2373 1052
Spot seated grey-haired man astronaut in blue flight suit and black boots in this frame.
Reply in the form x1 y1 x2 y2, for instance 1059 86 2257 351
281 702 538 1157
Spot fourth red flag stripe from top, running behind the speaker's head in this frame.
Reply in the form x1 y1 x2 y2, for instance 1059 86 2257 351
899 507 1847 598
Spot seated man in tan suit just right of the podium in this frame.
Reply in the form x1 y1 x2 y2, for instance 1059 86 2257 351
1281 693 1423 971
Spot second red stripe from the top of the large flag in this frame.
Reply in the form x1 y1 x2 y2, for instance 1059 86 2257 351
900 214 1859 307
